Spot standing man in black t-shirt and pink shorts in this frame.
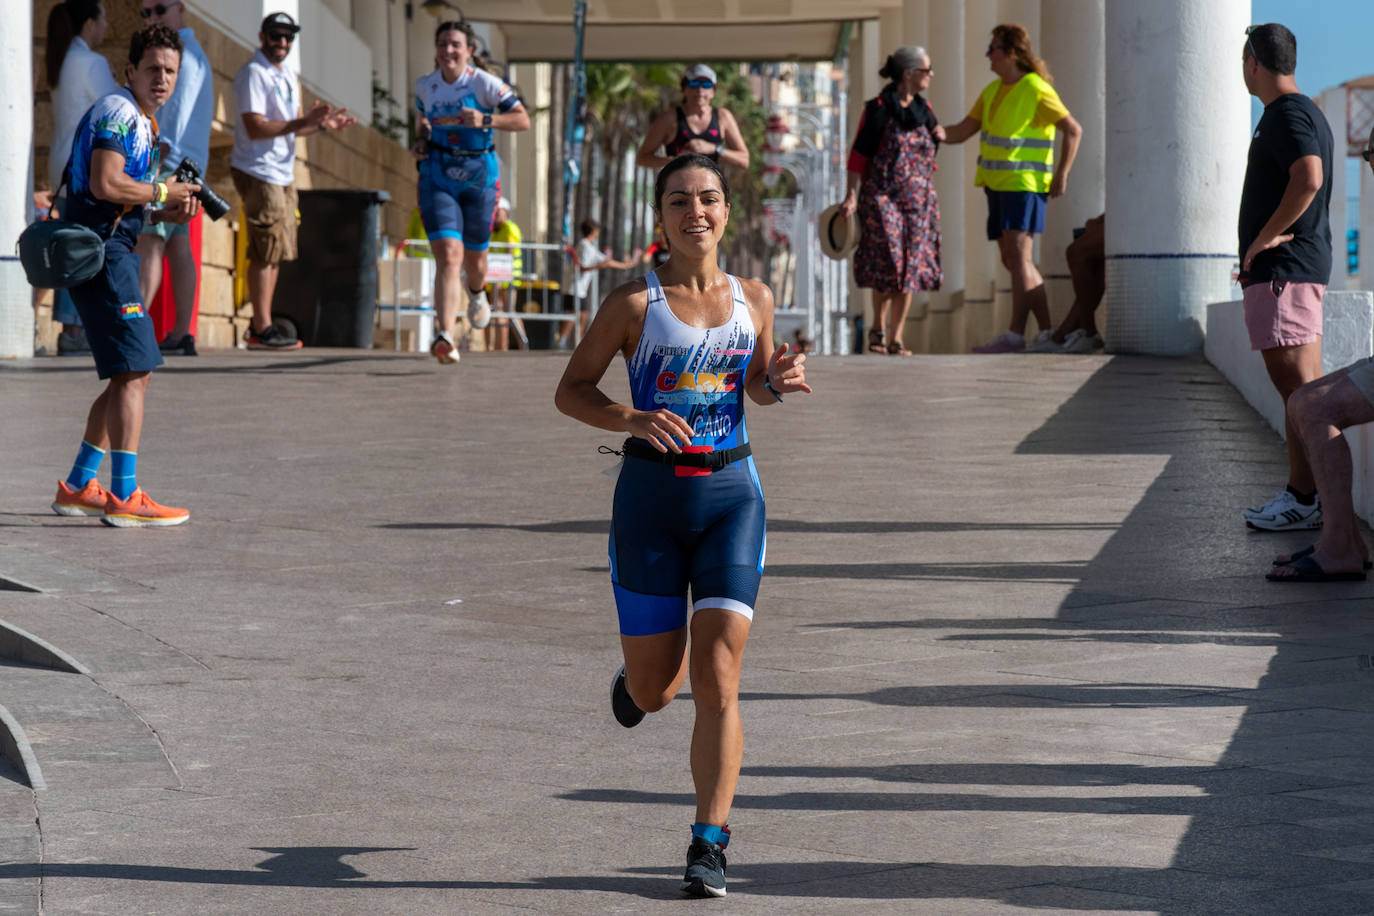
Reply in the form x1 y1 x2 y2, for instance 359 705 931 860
1239 22 1333 531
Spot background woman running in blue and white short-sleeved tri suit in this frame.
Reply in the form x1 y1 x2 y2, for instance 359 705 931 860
414 22 529 363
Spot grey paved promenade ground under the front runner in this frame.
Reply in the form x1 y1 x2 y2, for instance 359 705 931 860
0 350 1374 916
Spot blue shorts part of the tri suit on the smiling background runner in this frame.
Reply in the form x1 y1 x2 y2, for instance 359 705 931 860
419 152 500 251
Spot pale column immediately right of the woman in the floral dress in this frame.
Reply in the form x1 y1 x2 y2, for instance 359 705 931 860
922 3 976 353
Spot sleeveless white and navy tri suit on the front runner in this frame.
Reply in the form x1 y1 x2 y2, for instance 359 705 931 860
610 273 767 636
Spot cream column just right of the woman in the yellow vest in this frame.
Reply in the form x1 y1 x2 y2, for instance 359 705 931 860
1037 0 1106 325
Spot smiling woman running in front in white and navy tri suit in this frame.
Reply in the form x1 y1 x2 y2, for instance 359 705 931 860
555 154 811 897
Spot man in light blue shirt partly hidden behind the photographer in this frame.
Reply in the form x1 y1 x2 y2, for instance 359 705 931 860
136 0 214 356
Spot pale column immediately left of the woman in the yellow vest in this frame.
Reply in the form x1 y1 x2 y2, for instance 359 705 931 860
948 0 1006 350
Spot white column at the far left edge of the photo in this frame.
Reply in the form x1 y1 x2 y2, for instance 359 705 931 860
0 3 34 358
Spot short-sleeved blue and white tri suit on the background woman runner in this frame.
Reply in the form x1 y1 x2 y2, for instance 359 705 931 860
415 66 519 251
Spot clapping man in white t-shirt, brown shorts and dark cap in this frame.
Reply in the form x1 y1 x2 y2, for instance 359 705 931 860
229 12 357 350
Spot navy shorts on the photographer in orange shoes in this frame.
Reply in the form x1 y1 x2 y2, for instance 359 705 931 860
71 241 162 379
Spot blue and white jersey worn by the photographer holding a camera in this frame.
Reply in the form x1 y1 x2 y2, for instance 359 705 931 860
62 88 161 246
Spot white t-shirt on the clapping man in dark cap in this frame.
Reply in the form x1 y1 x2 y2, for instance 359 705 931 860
229 48 301 187
